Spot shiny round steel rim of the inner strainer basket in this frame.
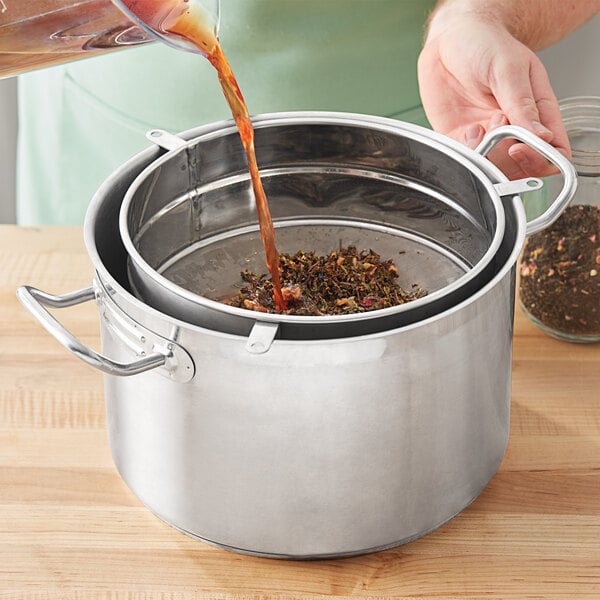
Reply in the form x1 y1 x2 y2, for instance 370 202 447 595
119 111 508 326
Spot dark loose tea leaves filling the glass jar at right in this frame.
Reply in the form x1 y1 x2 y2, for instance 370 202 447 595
520 204 600 335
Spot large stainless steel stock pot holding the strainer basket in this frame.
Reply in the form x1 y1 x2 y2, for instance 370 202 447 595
18 111 575 558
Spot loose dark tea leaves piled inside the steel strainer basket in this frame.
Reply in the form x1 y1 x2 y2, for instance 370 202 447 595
224 246 427 316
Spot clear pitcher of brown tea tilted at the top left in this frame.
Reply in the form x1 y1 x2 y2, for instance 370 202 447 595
0 0 220 78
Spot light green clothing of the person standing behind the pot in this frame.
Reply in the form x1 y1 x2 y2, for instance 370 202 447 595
17 0 435 225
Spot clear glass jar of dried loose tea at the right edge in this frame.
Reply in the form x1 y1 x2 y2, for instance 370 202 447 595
519 96 600 343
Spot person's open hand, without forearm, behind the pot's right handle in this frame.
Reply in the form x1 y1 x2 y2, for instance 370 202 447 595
418 15 571 179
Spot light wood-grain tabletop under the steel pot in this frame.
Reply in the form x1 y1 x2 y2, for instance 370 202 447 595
0 226 600 600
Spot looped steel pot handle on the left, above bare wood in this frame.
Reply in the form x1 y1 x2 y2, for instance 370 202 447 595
17 285 168 375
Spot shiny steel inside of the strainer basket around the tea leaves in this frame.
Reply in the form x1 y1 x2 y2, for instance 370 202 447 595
121 119 504 325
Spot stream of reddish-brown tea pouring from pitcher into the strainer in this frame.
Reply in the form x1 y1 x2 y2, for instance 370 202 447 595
123 0 287 311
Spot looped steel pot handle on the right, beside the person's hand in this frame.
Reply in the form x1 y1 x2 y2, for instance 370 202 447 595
475 125 577 235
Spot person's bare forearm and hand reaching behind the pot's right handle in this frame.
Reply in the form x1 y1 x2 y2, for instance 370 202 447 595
418 0 600 178
